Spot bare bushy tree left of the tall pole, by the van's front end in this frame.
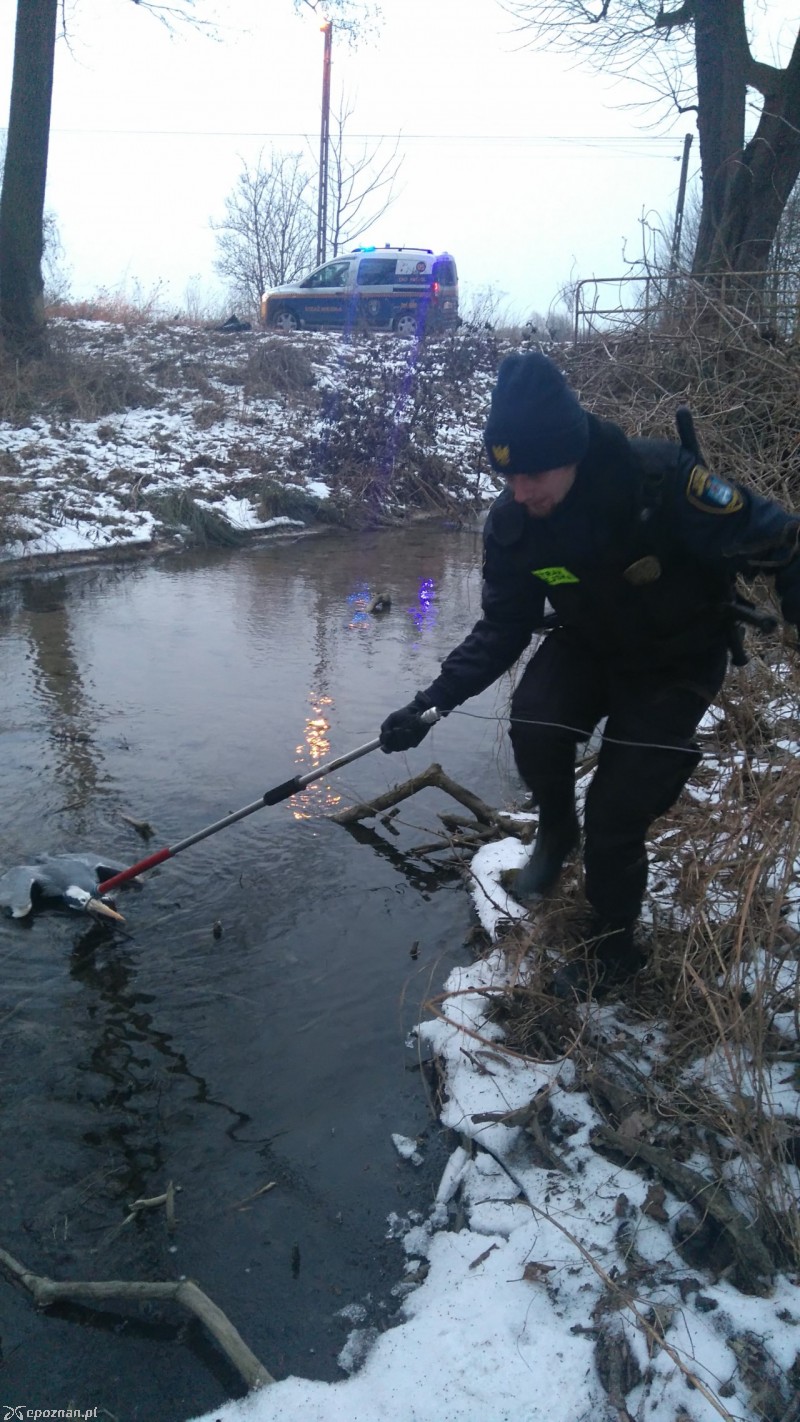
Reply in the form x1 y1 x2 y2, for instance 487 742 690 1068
212 152 317 310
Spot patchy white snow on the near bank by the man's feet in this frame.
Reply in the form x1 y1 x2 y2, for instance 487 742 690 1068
188 790 800 1422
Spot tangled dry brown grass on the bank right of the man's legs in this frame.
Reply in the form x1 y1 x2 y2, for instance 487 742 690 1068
454 636 800 1274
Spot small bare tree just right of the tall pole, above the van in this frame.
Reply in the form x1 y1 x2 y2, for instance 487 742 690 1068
327 94 402 257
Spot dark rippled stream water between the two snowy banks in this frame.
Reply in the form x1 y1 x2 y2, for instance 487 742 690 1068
0 528 517 1422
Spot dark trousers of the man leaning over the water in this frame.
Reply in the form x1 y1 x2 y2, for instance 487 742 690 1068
510 629 728 923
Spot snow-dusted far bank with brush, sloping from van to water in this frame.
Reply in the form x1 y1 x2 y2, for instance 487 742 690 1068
0 320 497 573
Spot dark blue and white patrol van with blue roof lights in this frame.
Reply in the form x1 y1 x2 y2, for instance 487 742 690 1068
261 246 459 336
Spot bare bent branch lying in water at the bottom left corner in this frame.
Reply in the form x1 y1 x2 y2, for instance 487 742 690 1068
0 1249 276 1388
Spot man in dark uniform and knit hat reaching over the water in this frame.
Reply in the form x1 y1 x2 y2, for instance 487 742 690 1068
381 354 800 991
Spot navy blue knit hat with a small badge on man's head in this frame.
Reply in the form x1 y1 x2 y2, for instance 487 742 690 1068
483 351 588 475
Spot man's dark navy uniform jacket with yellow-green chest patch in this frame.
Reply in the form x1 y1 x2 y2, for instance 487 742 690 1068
423 415 800 710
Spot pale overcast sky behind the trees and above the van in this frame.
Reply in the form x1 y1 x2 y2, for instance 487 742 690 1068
0 0 797 319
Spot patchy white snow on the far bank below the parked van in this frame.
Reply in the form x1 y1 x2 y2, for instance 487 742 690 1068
0 321 494 567
